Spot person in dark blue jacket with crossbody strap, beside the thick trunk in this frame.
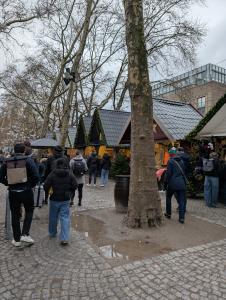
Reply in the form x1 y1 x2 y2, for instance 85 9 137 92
165 147 187 224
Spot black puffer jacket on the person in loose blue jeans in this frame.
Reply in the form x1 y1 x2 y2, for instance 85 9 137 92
44 169 77 201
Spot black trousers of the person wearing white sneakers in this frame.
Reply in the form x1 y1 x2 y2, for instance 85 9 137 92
9 190 34 242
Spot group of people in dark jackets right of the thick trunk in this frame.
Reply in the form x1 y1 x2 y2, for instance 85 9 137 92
164 143 226 224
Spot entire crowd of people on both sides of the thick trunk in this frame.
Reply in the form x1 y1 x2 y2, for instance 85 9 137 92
0 141 226 247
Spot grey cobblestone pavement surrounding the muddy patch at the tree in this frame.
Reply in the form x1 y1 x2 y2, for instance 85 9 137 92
0 183 226 300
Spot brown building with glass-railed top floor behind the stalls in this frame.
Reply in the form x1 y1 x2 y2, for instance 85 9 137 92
152 64 226 115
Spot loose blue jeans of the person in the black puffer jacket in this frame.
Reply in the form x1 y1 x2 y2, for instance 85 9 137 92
49 200 70 241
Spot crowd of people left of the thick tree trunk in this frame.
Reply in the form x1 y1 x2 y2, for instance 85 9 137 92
0 141 111 247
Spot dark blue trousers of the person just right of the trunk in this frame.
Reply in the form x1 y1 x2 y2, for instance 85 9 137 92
166 188 186 220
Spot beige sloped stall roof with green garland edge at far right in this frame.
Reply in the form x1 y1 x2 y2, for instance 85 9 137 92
187 94 226 140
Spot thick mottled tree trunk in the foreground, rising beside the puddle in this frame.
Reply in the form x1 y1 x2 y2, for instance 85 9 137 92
124 0 162 227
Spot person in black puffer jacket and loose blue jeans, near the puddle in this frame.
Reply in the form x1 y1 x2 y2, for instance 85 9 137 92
44 158 77 245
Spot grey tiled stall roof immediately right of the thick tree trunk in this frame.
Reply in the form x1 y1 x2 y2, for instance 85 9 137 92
153 99 203 141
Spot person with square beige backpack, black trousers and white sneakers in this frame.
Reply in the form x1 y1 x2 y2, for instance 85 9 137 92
0 144 39 247
